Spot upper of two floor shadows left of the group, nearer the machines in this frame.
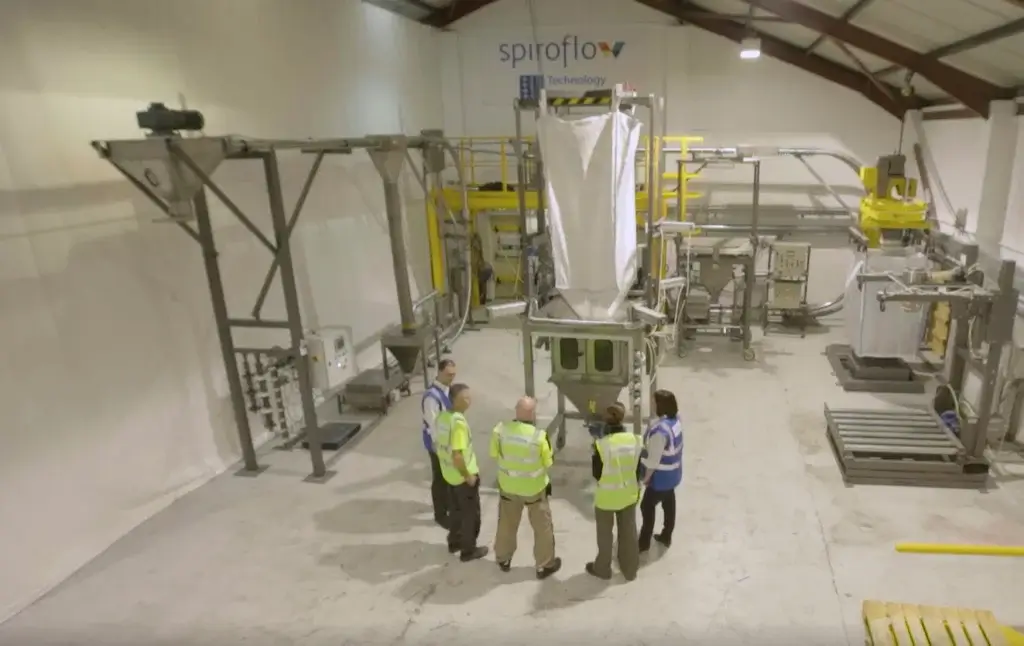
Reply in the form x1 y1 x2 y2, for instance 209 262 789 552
313 498 434 534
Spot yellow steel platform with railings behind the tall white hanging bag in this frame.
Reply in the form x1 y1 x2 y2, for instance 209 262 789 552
426 136 703 306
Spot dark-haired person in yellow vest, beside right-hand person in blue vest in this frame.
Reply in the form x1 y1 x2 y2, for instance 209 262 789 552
587 402 643 580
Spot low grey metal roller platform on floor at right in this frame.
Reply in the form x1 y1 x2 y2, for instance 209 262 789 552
825 405 988 488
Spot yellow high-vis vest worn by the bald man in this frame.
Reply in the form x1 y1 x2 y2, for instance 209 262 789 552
494 422 548 496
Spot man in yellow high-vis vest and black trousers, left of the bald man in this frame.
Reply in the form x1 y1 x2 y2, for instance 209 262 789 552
433 384 487 561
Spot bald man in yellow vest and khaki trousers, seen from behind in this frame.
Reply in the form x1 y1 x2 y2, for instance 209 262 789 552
490 397 562 578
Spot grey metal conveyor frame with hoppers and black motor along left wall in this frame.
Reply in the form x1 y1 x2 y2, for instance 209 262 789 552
92 104 456 481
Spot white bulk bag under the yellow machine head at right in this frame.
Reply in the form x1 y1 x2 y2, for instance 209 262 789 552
844 249 928 359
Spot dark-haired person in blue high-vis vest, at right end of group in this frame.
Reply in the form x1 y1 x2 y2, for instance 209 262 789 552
639 390 683 552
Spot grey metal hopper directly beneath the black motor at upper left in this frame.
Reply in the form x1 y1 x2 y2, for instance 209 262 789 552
104 137 227 220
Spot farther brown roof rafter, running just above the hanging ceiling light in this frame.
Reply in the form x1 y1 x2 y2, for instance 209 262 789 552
636 0 923 118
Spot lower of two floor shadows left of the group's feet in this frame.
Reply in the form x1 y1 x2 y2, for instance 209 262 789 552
319 541 449 585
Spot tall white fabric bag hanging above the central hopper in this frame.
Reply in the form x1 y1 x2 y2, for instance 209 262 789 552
537 111 643 320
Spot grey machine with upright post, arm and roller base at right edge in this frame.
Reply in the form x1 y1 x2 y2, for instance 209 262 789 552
825 233 1019 488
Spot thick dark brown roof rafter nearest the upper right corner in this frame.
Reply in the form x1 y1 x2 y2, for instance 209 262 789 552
743 0 1012 118
